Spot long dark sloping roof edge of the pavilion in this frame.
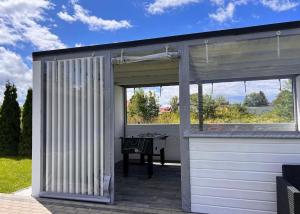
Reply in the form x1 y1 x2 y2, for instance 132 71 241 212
32 21 300 60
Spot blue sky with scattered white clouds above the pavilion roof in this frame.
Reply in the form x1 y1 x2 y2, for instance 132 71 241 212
0 0 300 103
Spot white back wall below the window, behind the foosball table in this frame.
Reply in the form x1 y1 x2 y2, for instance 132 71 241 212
126 124 180 161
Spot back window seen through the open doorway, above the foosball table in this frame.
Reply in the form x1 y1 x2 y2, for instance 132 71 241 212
126 86 179 124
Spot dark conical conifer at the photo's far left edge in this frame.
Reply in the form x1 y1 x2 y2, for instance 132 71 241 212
0 82 20 155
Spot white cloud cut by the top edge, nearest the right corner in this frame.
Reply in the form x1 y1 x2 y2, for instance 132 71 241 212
261 0 299 12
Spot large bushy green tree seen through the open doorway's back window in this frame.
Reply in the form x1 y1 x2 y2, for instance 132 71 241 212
128 89 159 122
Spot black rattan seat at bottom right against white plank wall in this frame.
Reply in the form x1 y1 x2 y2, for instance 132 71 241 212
276 165 300 214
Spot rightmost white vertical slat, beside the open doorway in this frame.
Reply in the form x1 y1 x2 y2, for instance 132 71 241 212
100 57 104 196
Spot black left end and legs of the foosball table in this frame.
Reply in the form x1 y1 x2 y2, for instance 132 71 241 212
121 137 153 178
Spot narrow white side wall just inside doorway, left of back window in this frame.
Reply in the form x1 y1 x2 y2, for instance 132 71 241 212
115 86 124 163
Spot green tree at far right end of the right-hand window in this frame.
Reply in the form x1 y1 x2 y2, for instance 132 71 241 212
273 90 294 122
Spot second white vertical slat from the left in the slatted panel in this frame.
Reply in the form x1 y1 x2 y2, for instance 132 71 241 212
51 61 57 192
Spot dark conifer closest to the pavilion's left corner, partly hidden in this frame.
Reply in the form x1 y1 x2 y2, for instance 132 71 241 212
18 89 32 156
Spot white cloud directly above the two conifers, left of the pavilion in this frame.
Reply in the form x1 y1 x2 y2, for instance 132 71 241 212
0 46 32 103
